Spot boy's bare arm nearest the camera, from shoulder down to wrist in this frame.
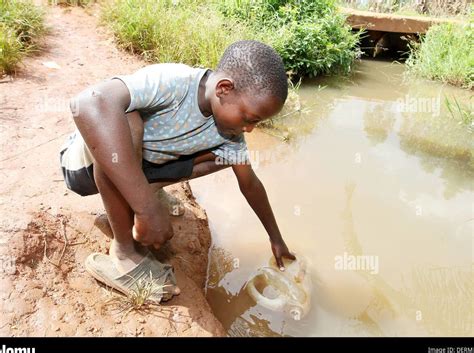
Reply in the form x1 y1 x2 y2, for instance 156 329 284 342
71 79 171 243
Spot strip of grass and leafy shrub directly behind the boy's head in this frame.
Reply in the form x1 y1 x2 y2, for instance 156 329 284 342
103 0 359 77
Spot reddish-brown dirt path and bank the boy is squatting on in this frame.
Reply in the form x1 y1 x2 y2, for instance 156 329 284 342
0 7 225 336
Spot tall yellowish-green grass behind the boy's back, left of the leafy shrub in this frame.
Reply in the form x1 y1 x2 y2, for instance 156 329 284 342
102 0 256 67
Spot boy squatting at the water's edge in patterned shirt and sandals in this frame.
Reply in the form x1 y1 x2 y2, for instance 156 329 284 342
60 41 294 301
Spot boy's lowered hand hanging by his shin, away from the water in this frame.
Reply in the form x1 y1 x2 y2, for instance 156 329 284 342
132 198 173 249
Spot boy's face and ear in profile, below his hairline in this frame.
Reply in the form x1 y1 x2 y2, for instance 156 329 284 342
211 79 283 135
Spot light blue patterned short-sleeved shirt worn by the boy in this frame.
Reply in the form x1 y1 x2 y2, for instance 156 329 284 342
113 64 248 164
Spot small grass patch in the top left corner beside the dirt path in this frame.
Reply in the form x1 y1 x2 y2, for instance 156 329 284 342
0 0 46 75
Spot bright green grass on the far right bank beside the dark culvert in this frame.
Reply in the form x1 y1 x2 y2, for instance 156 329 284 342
407 15 474 89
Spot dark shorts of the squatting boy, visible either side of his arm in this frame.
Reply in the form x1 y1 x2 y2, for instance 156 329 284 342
60 153 197 196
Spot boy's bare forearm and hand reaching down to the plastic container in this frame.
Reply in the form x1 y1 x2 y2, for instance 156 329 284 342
232 164 295 269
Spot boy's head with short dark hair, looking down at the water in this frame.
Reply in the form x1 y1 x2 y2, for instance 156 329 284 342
208 40 288 135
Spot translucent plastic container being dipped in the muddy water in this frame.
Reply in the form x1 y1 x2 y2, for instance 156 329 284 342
246 257 312 320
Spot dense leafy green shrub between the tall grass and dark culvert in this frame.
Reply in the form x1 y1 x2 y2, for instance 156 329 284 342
219 0 360 77
